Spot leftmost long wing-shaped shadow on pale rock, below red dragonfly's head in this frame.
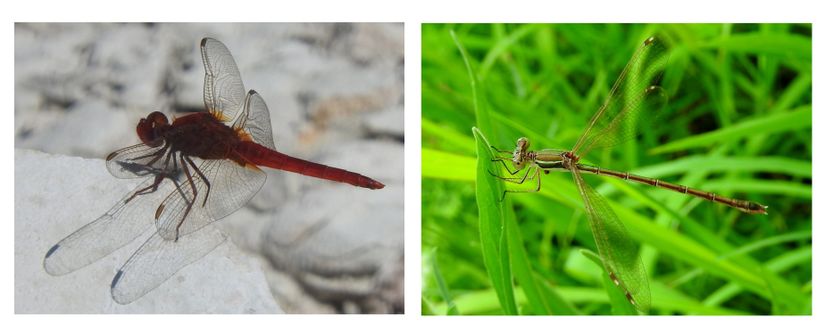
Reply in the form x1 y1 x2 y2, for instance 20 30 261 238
43 178 174 275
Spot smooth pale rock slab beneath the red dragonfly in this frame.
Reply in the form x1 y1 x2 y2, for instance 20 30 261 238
14 150 282 313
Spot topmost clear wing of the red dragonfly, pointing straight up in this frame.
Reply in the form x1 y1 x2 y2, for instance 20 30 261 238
201 37 246 120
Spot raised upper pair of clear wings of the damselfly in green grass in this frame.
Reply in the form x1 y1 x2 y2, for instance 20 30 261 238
572 37 668 156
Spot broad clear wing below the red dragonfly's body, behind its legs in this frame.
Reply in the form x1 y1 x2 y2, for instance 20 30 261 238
155 159 266 240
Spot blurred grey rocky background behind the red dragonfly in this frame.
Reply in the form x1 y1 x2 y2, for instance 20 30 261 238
14 23 404 313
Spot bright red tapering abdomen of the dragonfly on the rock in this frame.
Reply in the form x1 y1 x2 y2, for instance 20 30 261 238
235 141 384 189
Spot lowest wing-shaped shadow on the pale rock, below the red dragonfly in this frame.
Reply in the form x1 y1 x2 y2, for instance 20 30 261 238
111 227 226 304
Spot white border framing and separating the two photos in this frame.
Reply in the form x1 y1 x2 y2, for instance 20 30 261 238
0 0 825 334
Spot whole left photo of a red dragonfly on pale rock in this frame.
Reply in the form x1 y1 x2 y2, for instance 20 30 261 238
14 23 404 313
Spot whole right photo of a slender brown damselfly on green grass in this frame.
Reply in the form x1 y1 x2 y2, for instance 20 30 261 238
421 24 813 315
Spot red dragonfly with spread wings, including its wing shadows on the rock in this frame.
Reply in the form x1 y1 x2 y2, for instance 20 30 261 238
43 38 384 304
